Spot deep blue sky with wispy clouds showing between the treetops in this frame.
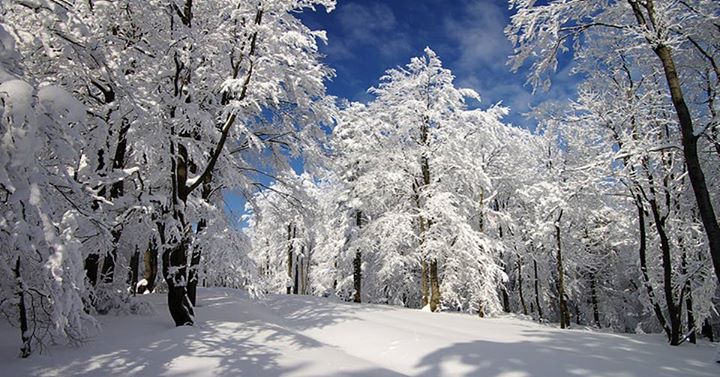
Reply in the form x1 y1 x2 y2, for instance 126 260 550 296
225 0 577 223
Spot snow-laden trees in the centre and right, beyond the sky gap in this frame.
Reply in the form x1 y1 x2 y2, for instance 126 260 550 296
248 0 720 345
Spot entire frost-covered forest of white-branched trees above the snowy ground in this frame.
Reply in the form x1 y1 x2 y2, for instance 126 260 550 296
0 0 720 368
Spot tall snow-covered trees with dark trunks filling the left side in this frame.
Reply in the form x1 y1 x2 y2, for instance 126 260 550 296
0 0 335 357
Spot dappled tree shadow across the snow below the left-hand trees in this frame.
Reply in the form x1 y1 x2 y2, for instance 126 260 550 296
10 290 401 377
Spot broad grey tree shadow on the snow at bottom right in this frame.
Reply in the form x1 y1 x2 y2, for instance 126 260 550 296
417 329 718 377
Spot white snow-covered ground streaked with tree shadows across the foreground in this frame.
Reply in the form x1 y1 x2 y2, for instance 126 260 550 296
0 289 720 377
